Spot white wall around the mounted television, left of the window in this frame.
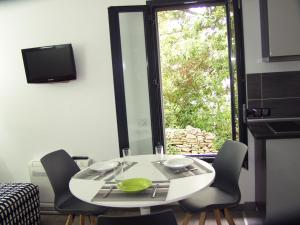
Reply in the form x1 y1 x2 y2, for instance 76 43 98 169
0 0 145 182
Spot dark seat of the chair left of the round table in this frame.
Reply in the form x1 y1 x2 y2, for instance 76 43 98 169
55 194 107 216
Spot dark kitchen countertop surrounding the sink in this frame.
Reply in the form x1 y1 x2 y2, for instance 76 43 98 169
247 121 300 139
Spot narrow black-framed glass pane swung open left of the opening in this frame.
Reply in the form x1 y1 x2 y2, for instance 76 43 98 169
109 6 153 155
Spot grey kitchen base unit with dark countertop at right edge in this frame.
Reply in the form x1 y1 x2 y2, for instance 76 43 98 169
247 119 300 224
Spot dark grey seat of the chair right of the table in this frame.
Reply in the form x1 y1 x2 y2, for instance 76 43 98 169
180 187 240 213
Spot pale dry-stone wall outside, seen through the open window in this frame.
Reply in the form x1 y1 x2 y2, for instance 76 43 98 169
165 126 217 154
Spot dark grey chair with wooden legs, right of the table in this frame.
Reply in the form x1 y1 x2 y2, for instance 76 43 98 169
179 140 248 225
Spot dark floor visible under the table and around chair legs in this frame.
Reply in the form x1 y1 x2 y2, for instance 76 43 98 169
41 206 262 225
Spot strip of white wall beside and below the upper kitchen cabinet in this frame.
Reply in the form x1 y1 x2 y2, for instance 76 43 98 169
243 0 300 74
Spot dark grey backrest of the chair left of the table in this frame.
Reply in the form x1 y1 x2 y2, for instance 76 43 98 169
41 149 80 204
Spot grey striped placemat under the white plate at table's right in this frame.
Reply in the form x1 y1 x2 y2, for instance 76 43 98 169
152 157 212 180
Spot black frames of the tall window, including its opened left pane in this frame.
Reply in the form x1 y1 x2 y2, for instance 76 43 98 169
108 0 247 158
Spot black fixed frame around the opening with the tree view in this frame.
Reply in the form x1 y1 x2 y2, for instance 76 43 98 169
147 0 248 145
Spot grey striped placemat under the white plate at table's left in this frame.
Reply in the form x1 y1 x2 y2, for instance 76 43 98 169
74 162 137 180
